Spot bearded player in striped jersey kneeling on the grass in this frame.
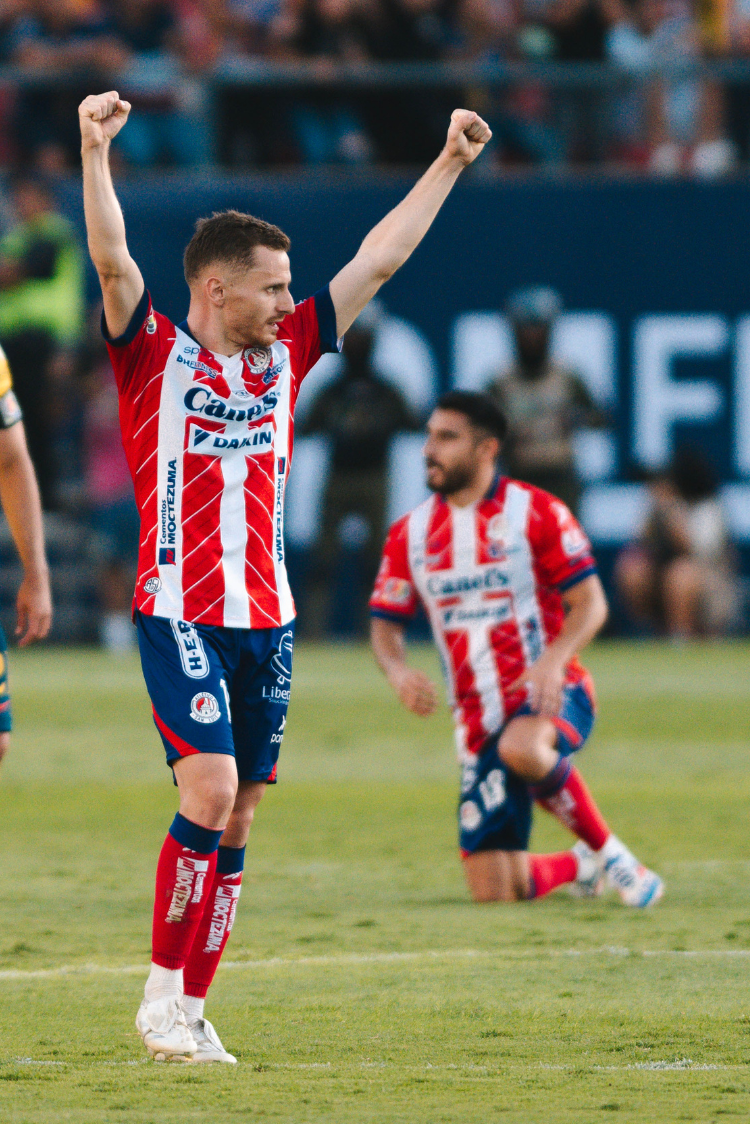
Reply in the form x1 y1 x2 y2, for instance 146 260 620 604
370 391 663 907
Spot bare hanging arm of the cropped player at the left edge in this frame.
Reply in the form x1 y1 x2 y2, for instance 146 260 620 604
0 422 52 647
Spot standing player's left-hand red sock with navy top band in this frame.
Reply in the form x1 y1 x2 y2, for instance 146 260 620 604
151 812 222 971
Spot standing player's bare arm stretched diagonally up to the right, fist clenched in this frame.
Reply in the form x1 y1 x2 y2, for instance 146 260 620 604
331 109 493 336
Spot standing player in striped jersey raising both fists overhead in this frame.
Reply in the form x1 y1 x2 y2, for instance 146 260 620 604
79 91 491 1062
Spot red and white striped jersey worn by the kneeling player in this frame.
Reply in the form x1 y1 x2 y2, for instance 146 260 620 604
370 478 596 758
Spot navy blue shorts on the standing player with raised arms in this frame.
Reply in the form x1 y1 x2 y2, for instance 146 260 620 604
135 611 295 785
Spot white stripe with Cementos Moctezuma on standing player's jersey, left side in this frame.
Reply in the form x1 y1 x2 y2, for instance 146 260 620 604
154 329 186 619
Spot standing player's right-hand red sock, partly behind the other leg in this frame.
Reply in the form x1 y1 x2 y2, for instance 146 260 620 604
184 846 245 999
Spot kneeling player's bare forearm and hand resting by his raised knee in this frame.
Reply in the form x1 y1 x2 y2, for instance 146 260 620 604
512 574 607 718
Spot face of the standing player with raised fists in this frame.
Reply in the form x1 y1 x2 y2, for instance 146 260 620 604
207 246 295 351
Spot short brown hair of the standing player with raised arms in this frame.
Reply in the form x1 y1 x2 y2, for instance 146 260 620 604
183 210 291 284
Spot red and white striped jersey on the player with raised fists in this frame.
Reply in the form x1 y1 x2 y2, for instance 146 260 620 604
103 288 337 628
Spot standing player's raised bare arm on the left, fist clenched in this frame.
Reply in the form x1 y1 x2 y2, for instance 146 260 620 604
79 90 144 337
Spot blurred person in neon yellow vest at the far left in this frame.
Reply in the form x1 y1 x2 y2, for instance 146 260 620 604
0 175 84 509
